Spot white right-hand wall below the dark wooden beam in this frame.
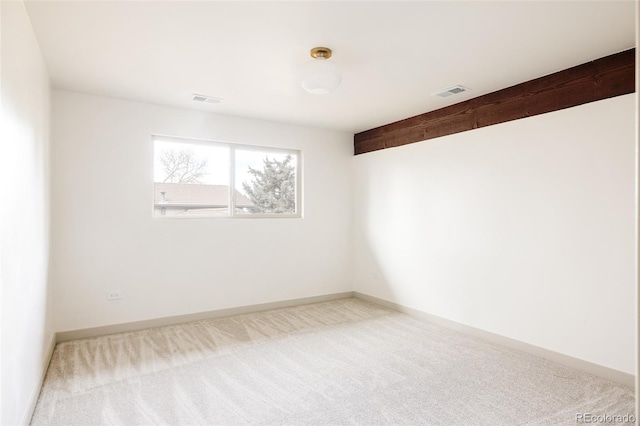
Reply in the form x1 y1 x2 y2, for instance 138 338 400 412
354 95 636 374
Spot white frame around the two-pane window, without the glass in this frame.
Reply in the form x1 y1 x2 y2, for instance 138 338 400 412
151 134 303 220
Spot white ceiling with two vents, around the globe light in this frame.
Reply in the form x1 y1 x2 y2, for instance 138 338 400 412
26 0 635 132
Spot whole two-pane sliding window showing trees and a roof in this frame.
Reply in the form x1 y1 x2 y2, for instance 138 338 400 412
153 137 300 217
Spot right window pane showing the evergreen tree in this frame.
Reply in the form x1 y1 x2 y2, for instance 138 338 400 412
235 148 298 214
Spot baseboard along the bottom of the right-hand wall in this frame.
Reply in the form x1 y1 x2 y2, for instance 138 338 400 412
353 291 636 387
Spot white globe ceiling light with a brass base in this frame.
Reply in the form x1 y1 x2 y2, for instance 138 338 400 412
300 47 342 95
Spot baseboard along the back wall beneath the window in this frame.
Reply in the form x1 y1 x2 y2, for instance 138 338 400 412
57 291 353 342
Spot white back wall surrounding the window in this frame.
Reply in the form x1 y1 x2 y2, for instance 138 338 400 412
52 91 353 331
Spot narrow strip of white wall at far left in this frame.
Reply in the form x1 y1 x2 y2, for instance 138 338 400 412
0 1 53 425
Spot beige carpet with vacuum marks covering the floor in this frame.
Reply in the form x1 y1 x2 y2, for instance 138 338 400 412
32 299 634 425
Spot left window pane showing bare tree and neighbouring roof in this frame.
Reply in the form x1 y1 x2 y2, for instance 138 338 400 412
153 140 229 216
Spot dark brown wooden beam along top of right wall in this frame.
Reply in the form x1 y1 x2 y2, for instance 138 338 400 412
354 49 635 155
